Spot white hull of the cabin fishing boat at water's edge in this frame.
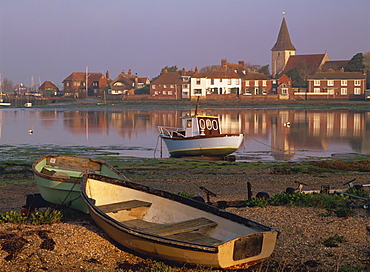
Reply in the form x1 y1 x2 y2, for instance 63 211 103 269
161 134 243 157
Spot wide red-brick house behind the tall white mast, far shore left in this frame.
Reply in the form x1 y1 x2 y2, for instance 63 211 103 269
63 72 109 98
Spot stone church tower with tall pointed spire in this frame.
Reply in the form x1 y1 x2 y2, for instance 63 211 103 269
271 17 296 78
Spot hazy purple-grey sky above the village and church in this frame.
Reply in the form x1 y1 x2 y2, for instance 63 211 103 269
0 0 370 87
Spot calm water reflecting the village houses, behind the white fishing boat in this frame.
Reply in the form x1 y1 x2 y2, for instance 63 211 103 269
0 108 370 161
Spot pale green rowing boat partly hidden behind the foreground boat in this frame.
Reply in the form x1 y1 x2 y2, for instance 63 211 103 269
32 154 123 212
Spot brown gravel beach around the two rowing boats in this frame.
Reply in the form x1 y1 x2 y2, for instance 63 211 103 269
0 162 370 271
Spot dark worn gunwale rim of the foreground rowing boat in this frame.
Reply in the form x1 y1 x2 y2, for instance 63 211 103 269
80 173 278 253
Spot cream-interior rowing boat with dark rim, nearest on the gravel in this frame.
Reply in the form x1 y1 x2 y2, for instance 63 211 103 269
81 174 278 269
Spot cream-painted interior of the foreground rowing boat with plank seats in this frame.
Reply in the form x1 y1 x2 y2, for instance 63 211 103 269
86 179 258 246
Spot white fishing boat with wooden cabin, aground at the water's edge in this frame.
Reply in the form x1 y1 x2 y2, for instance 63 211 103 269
158 99 243 157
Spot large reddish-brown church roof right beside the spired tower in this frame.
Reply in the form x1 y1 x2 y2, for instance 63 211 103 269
280 53 329 75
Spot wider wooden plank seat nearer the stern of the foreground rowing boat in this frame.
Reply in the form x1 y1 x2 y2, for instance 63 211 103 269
145 217 218 236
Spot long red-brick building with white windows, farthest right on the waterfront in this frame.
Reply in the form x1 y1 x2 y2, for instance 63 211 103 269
307 69 366 99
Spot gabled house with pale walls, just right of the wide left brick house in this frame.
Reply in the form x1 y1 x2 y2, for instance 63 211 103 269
110 69 150 95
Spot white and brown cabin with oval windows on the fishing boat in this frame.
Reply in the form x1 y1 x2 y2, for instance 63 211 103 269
179 115 221 137
